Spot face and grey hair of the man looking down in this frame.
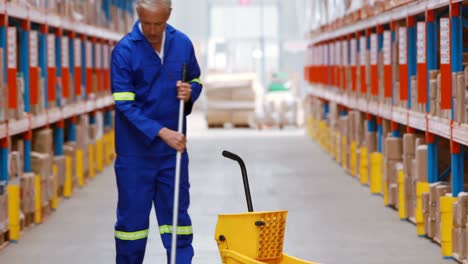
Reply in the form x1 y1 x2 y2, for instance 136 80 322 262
138 4 171 45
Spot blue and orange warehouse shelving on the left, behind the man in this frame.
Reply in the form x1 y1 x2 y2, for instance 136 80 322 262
0 1 131 247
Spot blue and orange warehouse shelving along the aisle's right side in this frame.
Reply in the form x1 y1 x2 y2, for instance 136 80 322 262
304 0 468 257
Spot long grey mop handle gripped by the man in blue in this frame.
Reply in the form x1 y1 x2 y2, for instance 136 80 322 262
171 63 187 264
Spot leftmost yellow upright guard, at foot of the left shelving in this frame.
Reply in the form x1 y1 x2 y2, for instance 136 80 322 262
7 184 20 242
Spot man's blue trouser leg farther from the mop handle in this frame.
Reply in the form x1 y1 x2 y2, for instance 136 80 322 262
115 156 156 264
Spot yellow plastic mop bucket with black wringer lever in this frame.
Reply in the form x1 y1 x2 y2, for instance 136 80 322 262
215 151 315 264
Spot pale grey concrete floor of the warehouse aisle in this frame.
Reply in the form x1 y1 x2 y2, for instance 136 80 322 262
0 113 455 264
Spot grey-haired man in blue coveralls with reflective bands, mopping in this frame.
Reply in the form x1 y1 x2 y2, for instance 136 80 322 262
111 0 202 264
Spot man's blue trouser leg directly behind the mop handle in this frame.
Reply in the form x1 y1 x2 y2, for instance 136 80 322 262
154 154 194 264
